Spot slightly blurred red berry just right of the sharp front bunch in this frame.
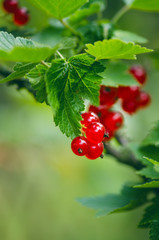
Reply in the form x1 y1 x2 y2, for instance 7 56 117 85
103 112 124 132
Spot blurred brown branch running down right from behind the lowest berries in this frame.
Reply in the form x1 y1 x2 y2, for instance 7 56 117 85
104 143 143 170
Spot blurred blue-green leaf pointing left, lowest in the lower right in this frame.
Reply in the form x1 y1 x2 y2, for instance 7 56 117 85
77 186 146 217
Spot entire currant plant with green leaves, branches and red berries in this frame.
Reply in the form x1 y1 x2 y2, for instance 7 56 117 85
0 0 159 240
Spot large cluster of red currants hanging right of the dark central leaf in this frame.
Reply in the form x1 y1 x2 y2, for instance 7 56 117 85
71 66 151 159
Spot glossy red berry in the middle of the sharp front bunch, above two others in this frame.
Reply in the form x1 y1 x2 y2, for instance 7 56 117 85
86 123 105 144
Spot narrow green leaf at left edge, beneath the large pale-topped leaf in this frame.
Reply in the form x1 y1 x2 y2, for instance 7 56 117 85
0 63 36 83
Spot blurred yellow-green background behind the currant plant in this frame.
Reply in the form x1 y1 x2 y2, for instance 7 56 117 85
0 0 159 240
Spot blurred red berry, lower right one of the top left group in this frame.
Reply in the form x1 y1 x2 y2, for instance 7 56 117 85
13 8 29 26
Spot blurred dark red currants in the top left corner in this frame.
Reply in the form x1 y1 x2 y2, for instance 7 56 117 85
3 0 29 26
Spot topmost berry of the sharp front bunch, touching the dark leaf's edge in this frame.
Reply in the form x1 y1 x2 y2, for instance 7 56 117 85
81 112 100 128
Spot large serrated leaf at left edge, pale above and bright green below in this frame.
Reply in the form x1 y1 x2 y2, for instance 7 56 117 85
0 32 57 62
